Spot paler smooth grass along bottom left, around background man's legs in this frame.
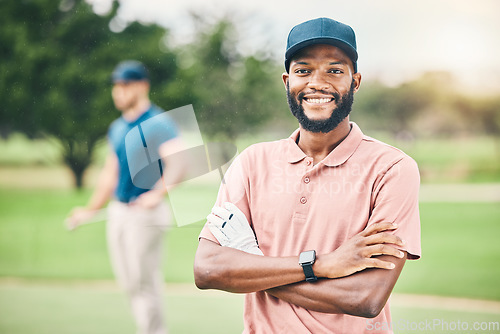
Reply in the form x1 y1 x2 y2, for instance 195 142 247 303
0 283 243 334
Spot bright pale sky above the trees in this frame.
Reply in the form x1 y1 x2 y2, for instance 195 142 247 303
88 0 500 91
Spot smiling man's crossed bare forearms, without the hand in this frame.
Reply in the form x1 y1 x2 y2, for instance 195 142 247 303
195 239 405 318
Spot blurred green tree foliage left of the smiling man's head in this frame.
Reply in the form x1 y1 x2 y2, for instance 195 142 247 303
0 0 285 187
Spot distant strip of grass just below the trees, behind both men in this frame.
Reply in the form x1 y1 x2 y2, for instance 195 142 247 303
0 132 500 183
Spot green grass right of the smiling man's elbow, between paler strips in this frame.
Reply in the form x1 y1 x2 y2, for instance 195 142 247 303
395 203 500 300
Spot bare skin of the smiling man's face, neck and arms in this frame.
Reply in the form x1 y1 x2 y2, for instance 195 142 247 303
194 45 407 317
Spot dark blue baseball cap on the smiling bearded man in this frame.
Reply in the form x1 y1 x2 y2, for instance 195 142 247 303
285 17 358 72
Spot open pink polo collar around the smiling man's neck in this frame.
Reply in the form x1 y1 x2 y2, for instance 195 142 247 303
287 122 363 167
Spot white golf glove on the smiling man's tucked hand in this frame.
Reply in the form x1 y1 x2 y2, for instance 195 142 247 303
207 202 264 255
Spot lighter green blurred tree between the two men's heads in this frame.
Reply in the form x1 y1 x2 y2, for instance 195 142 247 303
177 13 286 140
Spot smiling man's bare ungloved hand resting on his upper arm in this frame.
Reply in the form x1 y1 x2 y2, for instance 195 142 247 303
313 223 405 278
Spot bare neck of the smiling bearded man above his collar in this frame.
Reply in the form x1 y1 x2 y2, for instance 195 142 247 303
297 117 351 164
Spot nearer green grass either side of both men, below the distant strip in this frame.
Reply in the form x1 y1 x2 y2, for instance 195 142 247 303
0 186 500 334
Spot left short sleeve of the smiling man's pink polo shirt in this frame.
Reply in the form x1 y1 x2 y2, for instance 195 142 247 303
198 151 252 242
